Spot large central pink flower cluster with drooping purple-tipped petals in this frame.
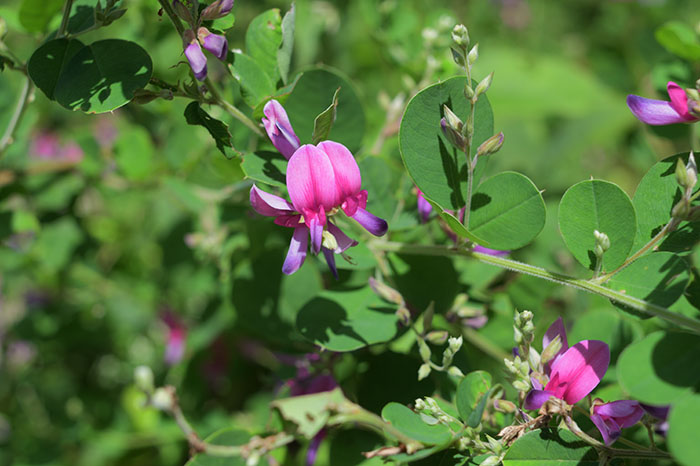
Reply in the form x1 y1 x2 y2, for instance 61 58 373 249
250 100 388 277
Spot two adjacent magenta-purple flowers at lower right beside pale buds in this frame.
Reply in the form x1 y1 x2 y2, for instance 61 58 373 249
524 318 644 445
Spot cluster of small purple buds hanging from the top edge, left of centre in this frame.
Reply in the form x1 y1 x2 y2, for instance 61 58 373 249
173 0 233 81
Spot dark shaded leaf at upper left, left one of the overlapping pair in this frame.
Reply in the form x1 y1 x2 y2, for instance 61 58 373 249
27 39 85 100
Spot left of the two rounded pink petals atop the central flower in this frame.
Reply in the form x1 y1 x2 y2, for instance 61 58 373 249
287 144 339 215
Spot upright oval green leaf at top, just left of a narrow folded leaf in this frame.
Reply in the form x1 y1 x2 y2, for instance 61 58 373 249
245 8 282 84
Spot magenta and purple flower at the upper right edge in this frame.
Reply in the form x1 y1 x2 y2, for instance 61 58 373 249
627 81 699 125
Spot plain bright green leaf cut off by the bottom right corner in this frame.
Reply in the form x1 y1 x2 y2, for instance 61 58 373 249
667 394 700 466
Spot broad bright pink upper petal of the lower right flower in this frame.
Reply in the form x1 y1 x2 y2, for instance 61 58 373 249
545 340 610 404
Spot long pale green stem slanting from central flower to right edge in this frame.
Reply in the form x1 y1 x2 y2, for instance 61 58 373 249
369 240 700 335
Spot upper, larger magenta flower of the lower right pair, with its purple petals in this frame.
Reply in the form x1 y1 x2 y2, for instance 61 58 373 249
525 319 610 409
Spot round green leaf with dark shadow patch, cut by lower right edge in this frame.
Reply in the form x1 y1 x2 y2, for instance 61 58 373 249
617 331 700 404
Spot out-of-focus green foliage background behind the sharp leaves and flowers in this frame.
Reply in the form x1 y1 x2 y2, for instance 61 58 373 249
0 0 700 466
